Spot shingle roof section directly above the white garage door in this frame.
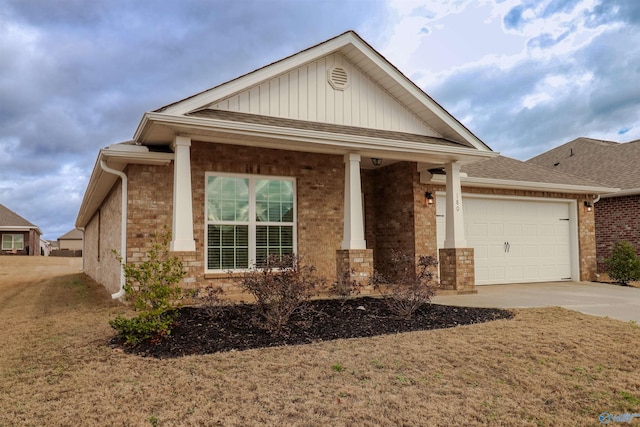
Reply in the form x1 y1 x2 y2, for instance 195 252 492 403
462 156 603 187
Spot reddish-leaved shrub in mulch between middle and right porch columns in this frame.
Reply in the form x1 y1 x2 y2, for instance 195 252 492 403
373 251 438 318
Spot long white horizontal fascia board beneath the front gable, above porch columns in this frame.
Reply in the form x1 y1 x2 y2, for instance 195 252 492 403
135 113 500 163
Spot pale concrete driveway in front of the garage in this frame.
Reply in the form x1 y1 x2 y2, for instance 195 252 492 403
433 282 640 323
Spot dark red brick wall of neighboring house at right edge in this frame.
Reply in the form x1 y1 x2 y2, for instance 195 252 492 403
594 196 640 273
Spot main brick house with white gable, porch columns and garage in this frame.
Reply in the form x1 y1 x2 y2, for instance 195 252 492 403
76 31 611 297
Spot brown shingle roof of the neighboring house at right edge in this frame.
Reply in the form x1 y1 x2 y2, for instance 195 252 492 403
527 138 640 190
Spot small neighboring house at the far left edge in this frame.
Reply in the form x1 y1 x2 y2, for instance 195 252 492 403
0 204 42 255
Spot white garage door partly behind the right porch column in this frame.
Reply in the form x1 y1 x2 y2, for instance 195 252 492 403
436 195 574 285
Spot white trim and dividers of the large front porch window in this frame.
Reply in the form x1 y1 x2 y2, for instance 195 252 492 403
203 171 298 274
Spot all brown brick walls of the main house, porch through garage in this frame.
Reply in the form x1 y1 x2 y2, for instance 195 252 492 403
85 145 595 295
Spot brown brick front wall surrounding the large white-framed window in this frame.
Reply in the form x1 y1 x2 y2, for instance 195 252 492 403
114 141 344 295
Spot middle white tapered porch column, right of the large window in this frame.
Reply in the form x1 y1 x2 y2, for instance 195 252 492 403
342 154 367 249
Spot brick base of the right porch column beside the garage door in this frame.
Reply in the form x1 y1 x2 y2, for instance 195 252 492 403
438 248 478 294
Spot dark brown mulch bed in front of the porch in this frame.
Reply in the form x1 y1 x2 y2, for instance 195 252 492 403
111 297 513 358
